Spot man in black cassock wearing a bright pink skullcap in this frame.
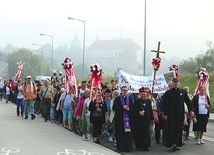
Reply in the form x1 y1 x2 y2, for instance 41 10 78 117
132 87 154 151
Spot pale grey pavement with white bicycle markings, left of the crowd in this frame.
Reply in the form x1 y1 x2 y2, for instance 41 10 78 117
0 101 118 155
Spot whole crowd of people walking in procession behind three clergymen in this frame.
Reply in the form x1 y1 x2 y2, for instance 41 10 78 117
0 76 211 152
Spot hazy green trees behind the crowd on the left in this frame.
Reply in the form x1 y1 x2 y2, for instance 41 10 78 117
0 48 89 78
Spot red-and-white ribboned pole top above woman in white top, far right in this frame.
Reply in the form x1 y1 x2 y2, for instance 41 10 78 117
194 68 209 96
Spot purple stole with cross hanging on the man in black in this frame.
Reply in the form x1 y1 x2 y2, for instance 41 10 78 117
120 95 131 132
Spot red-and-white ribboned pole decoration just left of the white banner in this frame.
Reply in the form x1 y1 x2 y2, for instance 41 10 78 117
90 63 102 99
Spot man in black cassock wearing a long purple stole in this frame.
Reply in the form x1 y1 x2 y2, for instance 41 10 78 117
112 86 133 152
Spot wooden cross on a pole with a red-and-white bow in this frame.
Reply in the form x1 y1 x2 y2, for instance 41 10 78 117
151 41 165 94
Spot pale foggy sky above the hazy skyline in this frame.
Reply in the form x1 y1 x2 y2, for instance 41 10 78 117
0 0 214 58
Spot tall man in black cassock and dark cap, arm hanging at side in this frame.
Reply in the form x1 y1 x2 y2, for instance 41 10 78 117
163 78 194 151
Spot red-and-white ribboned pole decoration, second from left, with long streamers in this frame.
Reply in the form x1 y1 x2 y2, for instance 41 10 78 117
62 57 78 95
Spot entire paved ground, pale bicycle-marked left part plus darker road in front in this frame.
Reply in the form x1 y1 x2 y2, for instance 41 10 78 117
0 100 214 155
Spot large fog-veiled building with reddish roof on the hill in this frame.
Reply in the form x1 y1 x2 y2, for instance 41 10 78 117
85 39 142 75
